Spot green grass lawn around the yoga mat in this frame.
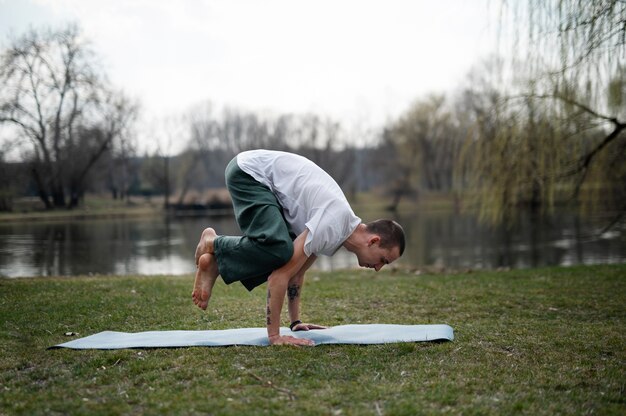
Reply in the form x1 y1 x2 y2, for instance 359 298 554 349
0 265 626 415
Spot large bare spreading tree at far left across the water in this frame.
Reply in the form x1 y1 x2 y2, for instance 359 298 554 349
0 26 136 208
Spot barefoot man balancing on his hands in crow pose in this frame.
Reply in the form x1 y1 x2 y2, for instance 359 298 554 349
192 150 405 345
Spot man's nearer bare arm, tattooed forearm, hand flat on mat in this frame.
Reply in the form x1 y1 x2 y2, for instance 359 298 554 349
266 230 313 345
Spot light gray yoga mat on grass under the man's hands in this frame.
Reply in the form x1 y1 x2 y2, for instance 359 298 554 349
51 324 454 350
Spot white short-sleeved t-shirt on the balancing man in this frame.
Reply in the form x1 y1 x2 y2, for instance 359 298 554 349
237 150 361 257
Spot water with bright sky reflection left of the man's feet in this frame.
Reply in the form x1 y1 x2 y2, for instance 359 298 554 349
0 218 236 277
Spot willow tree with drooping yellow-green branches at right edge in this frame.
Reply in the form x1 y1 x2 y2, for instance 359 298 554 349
465 0 626 228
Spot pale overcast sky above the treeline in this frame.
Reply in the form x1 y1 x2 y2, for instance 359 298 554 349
0 0 495 153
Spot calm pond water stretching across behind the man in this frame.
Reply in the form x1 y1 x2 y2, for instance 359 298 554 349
0 212 626 277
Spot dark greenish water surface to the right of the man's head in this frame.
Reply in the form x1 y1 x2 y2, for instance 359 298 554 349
398 208 626 269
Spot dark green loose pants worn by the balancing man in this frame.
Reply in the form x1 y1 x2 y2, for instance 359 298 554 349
214 159 294 290
